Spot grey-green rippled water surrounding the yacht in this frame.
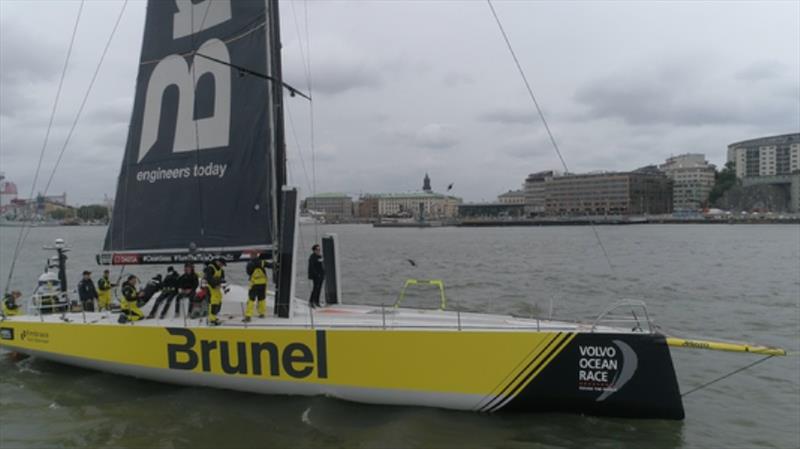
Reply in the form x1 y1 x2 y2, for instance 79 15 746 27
0 225 800 448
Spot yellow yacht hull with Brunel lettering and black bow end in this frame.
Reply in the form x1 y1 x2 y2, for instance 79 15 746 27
0 320 683 419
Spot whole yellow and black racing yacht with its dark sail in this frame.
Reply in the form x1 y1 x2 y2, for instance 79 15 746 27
0 0 781 419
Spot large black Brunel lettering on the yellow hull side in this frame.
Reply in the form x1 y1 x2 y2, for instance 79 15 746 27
167 328 328 379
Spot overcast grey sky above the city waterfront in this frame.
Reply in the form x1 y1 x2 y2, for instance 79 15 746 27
0 0 800 204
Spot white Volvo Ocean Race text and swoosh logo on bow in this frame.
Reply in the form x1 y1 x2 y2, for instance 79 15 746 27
578 340 639 402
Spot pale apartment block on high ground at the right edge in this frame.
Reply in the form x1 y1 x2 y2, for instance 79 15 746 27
728 133 800 179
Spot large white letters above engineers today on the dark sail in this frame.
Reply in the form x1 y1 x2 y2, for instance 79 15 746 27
137 0 232 162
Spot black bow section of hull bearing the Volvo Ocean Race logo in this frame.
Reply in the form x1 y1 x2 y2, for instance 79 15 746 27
501 334 684 419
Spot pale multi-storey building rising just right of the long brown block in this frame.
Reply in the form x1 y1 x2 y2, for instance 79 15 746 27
659 153 715 211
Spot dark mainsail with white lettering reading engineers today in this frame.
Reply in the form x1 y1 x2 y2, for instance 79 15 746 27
99 0 285 264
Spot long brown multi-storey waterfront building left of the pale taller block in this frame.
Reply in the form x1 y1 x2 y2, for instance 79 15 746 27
543 167 672 216
